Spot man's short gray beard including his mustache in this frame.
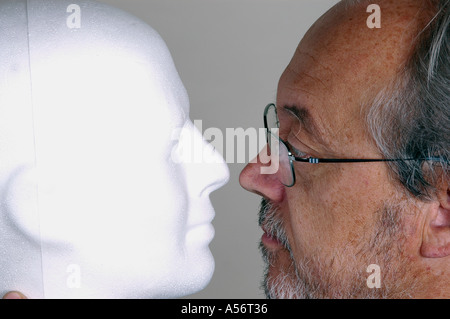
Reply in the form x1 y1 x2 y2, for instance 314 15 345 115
259 199 420 299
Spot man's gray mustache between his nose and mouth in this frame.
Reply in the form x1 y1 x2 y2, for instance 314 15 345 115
258 197 290 251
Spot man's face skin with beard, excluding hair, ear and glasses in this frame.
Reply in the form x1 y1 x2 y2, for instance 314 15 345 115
240 3 430 298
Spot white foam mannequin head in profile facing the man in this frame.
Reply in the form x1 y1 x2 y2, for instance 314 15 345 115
0 0 228 298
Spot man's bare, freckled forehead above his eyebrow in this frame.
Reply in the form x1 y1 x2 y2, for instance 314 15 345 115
289 0 428 92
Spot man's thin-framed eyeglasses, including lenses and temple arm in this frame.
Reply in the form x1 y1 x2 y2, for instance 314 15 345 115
264 103 444 187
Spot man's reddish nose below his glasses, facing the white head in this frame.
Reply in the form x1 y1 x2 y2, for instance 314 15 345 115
239 146 285 202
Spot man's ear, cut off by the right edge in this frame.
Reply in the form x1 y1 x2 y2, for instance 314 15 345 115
420 181 450 258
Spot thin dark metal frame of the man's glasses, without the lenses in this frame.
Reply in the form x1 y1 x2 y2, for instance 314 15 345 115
264 103 446 187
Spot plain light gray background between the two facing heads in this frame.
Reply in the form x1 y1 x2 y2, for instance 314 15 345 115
98 0 338 298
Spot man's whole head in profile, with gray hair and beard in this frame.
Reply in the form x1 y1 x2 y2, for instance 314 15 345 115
240 0 450 298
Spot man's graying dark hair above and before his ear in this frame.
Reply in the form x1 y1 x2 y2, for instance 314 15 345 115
366 0 450 200
